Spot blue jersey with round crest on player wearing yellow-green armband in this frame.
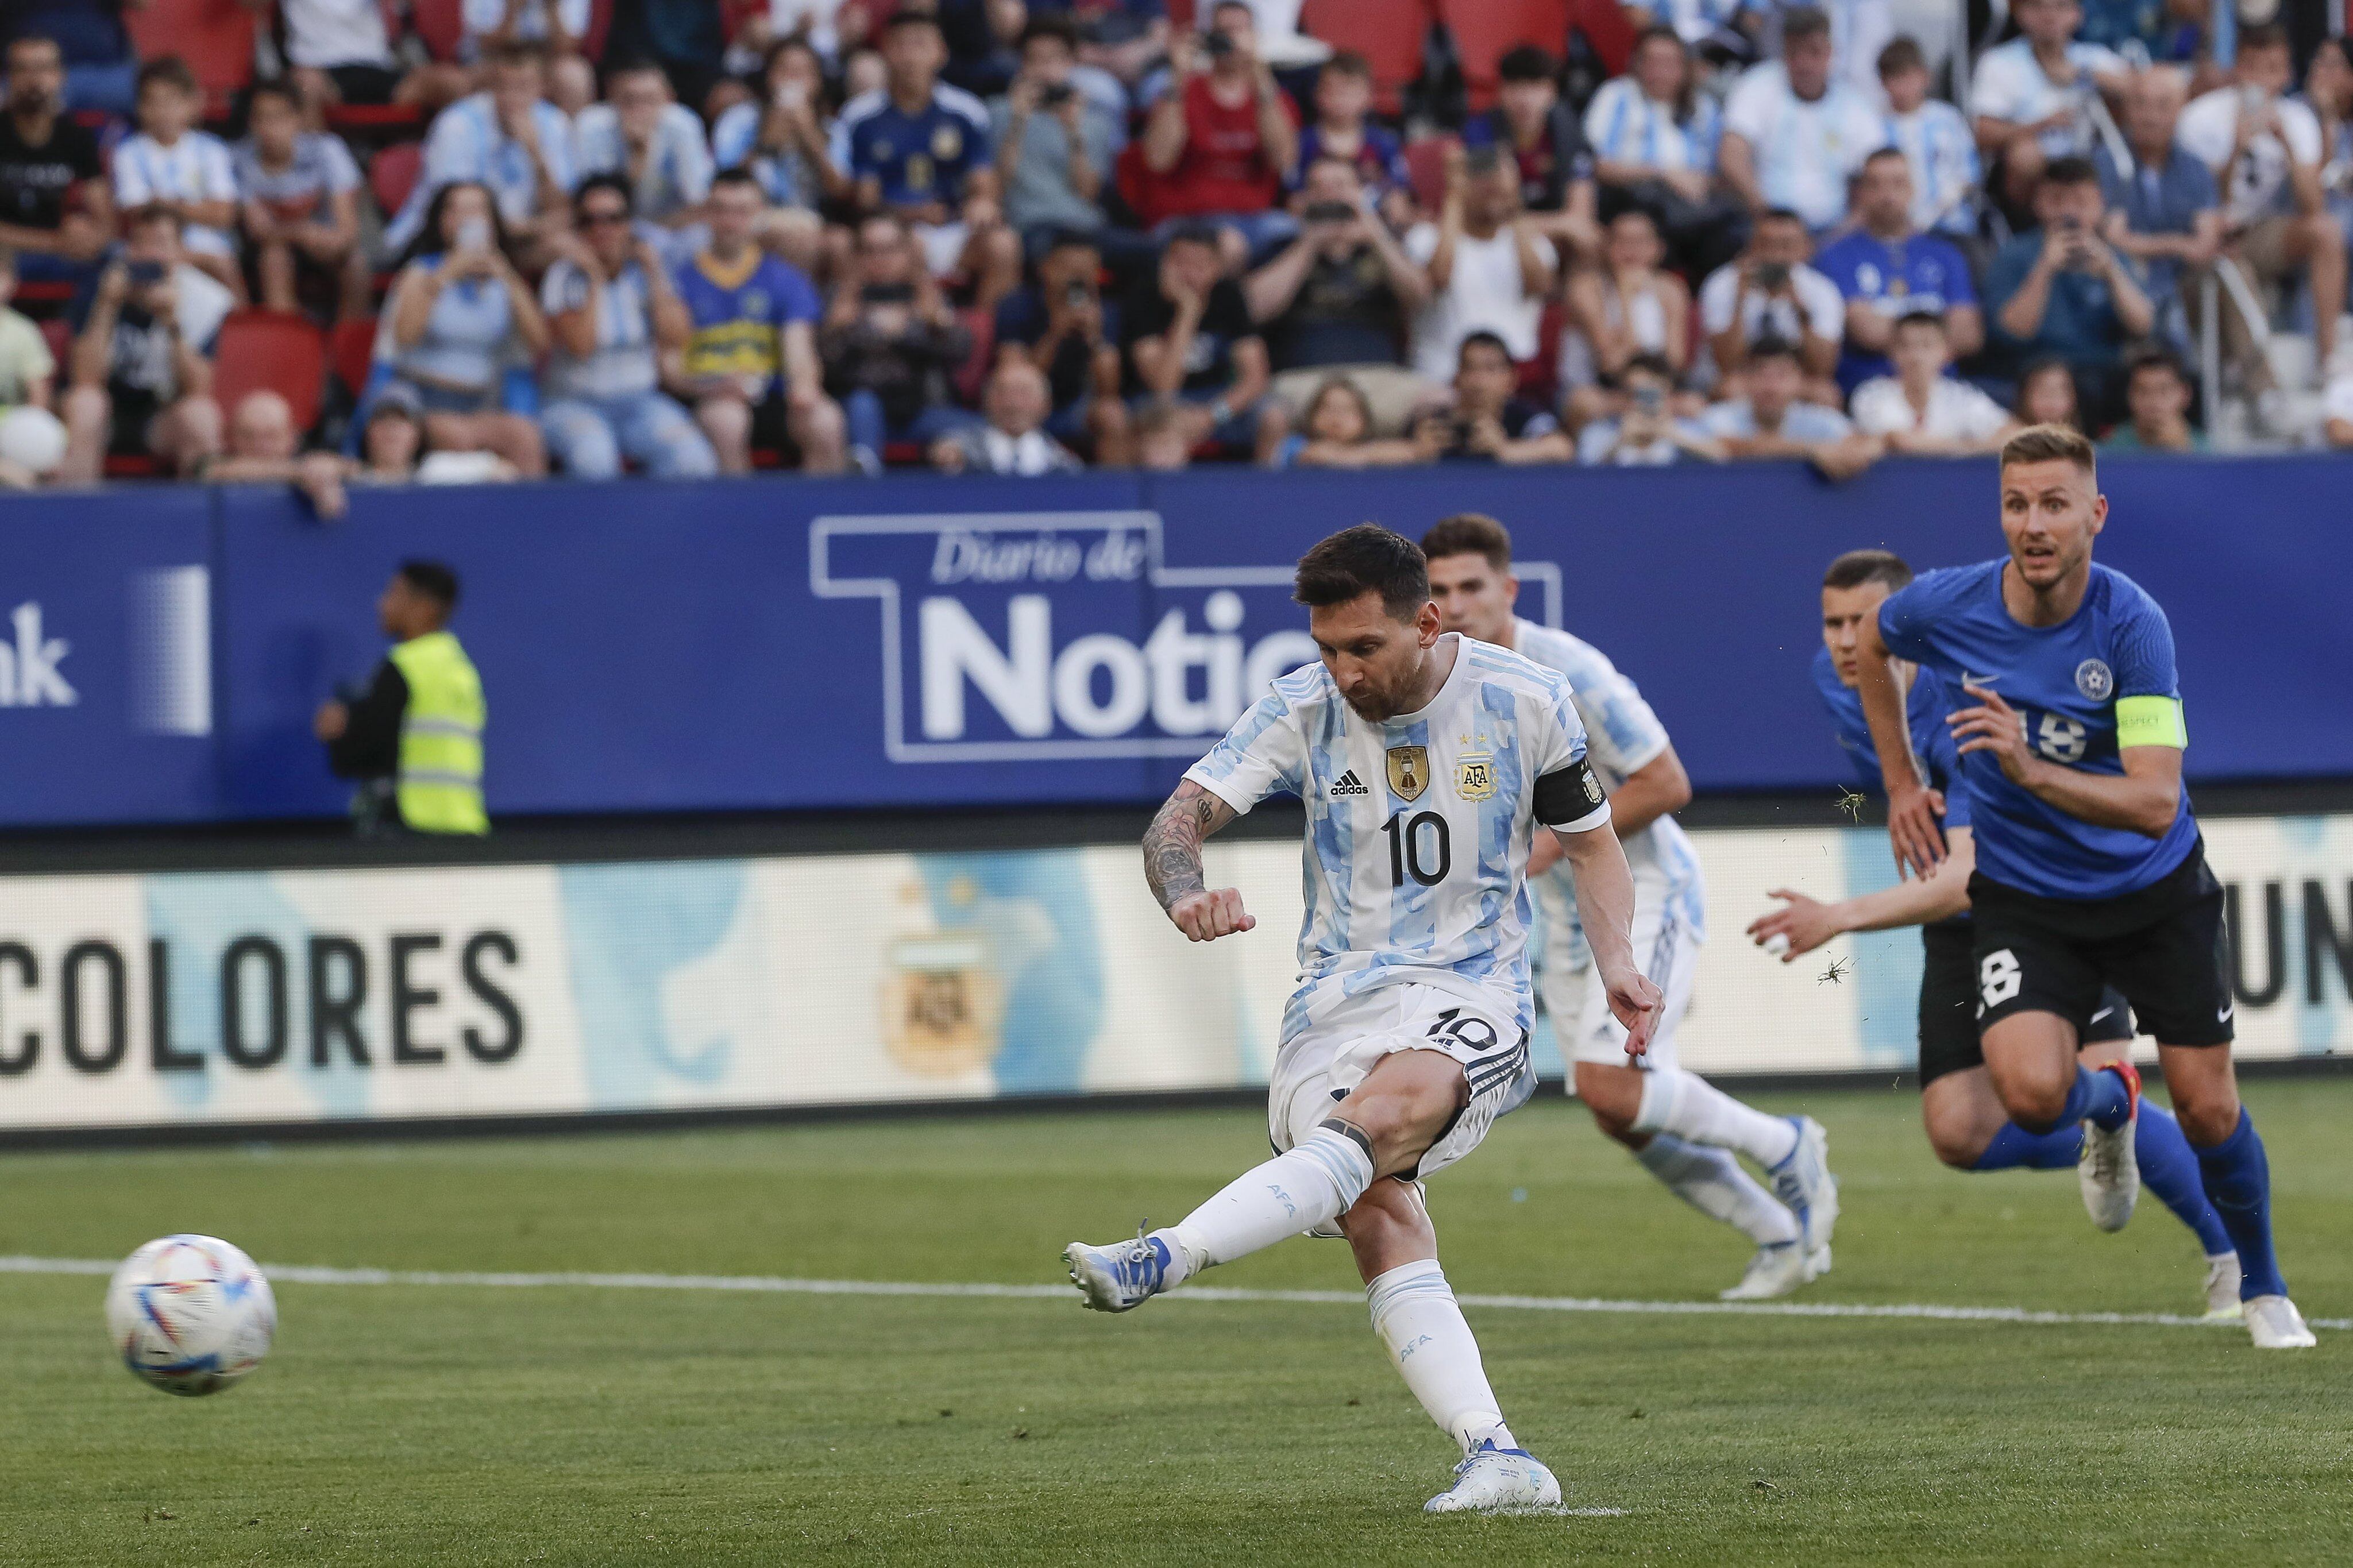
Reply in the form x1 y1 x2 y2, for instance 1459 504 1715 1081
1880 557 2198 898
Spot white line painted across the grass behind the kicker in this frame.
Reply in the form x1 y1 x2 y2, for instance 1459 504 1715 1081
0 1256 2353 1328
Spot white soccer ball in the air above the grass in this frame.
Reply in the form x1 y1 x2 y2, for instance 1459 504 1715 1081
106 1237 277 1396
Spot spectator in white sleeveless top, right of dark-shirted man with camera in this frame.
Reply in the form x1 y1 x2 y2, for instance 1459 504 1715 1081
1405 148 1555 385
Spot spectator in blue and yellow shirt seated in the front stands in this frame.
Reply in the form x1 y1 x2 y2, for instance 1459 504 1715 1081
678 169 844 473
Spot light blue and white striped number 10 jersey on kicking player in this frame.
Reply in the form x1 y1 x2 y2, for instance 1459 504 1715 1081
1186 632 1610 1039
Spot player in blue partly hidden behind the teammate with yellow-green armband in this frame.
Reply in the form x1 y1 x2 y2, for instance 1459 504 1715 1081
1760 550 2240 1321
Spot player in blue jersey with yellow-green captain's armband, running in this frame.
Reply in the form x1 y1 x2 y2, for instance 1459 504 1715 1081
1857 426 2313 1349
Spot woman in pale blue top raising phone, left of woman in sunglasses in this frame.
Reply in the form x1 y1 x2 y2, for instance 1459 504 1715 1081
374 181 548 480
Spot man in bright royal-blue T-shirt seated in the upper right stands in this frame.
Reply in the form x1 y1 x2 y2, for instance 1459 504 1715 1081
1814 148 1986 397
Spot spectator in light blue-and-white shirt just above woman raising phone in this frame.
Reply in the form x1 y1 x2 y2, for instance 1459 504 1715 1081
384 43 579 268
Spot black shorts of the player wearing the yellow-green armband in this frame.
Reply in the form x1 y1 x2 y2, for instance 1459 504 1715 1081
1969 839 2233 1046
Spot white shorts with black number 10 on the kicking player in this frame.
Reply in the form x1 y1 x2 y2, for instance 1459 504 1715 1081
1266 980 1537 1203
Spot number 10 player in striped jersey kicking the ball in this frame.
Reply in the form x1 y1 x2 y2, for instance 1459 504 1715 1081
1063 524 1659 1514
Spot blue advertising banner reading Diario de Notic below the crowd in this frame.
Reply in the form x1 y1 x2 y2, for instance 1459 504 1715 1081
0 458 2353 823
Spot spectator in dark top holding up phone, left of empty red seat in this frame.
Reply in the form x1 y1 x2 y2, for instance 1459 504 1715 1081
59 207 236 484
